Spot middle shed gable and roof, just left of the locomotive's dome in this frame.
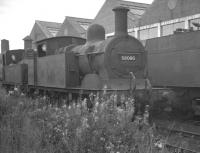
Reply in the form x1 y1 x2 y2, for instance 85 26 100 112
57 16 92 37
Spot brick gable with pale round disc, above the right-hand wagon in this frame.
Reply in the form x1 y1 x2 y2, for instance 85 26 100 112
140 0 200 26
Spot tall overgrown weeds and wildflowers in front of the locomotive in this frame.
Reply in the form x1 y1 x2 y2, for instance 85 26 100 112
0 90 168 153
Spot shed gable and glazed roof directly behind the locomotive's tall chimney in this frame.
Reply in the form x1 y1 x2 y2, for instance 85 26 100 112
93 0 149 33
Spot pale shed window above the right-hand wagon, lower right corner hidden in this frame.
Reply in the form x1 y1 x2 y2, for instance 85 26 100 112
162 22 185 36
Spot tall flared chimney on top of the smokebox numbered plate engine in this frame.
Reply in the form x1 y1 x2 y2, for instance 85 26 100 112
113 6 129 36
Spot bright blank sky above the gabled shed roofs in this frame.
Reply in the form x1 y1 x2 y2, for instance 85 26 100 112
0 0 153 49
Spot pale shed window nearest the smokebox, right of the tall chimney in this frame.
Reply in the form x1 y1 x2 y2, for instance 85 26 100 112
139 27 158 40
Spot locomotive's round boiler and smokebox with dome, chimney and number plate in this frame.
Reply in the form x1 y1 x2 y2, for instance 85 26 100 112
66 7 146 90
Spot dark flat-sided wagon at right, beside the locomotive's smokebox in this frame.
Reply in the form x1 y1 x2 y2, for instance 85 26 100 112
146 31 200 113
